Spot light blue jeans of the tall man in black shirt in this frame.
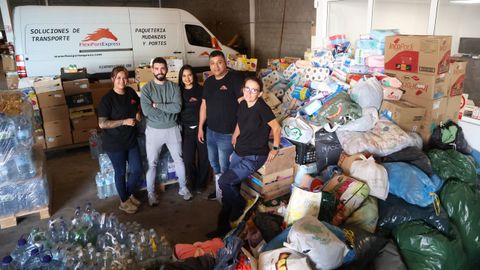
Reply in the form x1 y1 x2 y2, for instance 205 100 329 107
206 128 233 174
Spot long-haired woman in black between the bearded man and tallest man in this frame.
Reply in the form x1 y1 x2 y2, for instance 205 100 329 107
178 65 210 193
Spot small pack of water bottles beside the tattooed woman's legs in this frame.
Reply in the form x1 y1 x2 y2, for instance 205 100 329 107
95 153 117 199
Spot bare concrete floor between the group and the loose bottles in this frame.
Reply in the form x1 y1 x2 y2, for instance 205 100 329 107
0 147 220 257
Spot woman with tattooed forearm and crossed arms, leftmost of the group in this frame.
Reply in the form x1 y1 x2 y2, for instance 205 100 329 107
98 66 143 214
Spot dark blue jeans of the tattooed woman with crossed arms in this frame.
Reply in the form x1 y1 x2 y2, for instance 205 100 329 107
107 146 143 202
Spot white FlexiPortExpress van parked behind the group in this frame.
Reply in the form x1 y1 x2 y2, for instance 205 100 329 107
13 6 237 77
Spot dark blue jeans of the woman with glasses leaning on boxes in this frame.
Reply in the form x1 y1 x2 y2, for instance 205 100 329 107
217 152 268 233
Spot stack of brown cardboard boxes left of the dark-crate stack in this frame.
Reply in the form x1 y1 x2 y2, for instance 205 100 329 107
33 78 72 148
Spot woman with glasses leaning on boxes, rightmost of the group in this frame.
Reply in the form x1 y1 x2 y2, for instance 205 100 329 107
207 78 281 238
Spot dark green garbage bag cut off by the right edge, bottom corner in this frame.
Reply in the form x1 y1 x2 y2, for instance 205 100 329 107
440 179 480 266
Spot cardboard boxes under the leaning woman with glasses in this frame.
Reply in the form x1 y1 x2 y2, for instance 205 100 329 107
241 138 295 200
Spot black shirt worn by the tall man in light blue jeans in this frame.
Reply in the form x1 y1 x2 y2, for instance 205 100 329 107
203 71 243 134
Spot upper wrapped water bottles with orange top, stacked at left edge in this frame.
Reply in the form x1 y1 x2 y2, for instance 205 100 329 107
0 91 36 183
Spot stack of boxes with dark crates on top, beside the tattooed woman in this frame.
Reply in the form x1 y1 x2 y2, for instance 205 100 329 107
63 78 98 143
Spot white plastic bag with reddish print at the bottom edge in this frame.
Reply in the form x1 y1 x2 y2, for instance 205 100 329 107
258 247 312 270
